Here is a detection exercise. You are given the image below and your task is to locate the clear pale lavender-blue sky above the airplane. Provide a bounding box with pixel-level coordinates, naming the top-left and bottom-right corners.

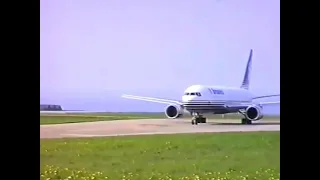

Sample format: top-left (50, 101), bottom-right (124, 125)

top-left (40, 0), bottom-right (280, 111)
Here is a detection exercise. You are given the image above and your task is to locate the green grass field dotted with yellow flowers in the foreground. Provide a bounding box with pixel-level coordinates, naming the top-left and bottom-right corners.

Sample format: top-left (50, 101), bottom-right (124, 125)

top-left (40, 132), bottom-right (280, 180)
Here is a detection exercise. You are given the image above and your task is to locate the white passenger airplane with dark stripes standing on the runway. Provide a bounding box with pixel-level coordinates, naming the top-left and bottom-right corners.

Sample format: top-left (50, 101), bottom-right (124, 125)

top-left (122, 49), bottom-right (280, 125)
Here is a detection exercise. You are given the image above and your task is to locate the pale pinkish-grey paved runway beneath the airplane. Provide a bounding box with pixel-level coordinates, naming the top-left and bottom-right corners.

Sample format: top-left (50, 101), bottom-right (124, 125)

top-left (40, 119), bottom-right (280, 139)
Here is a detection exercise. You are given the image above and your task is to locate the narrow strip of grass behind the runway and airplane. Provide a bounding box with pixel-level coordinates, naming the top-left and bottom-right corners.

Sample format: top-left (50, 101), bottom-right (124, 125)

top-left (40, 113), bottom-right (279, 125)
